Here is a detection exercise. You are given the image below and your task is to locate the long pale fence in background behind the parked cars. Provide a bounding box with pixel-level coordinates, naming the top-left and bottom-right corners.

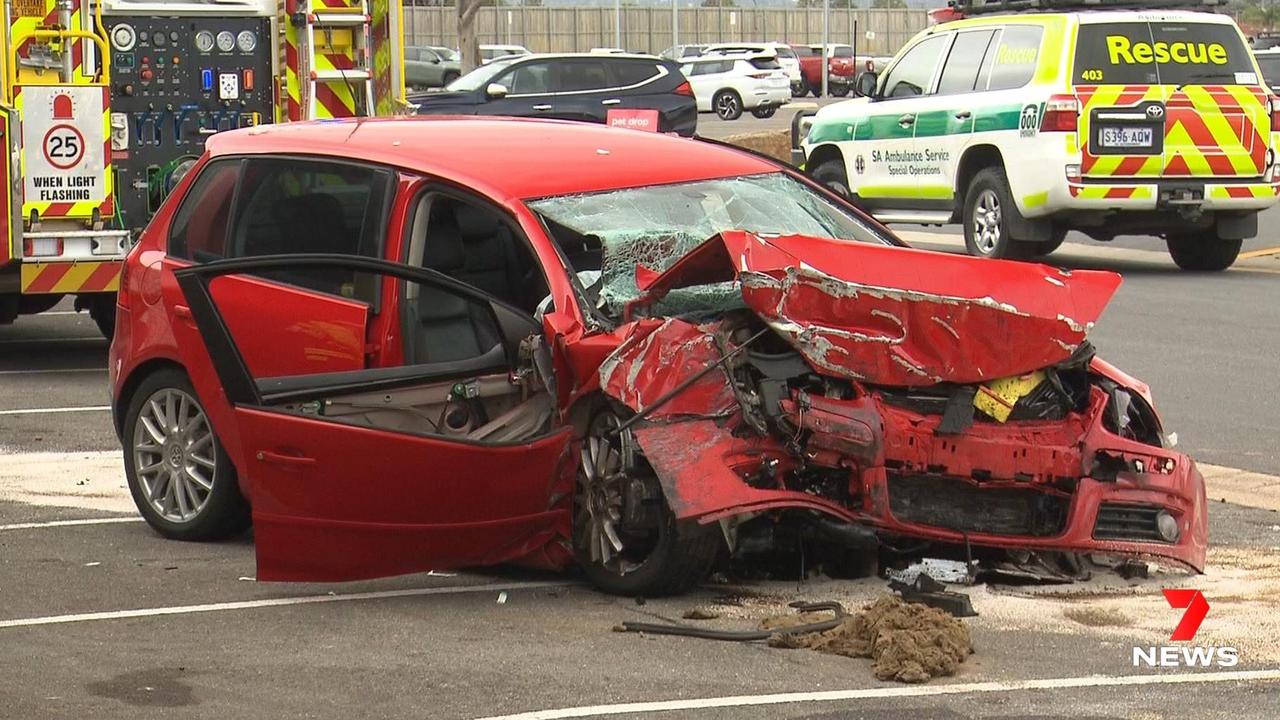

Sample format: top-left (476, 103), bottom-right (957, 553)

top-left (404, 6), bottom-right (928, 55)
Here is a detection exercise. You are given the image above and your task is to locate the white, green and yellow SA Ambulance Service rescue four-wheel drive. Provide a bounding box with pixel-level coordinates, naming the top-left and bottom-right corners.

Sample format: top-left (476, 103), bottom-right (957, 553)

top-left (803, 0), bottom-right (1280, 270)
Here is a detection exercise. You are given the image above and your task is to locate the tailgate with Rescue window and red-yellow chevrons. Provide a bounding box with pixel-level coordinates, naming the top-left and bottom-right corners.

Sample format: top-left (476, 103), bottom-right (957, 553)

top-left (1073, 17), bottom-right (1271, 181)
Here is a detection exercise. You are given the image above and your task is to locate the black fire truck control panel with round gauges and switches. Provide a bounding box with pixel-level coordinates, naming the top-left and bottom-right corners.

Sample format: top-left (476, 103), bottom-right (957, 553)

top-left (102, 15), bottom-right (274, 227)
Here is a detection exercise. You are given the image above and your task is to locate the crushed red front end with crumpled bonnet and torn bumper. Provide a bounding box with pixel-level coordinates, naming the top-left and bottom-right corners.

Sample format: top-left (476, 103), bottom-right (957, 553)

top-left (600, 233), bottom-right (1208, 570)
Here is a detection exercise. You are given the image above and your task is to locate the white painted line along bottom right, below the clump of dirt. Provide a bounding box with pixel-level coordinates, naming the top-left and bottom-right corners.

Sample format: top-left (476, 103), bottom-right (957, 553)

top-left (477, 670), bottom-right (1280, 720)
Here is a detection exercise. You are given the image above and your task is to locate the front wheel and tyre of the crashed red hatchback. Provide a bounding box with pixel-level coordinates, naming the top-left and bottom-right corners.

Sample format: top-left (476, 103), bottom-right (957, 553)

top-left (573, 409), bottom-right (724, 597)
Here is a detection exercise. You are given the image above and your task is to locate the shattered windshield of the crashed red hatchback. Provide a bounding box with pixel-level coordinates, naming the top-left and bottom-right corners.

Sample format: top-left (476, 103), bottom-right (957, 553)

top-left (529, 173), bottom-right (890, 319)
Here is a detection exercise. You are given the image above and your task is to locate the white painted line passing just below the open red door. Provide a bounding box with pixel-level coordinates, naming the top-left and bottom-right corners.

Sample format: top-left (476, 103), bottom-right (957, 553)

top-left (0, 582), bottom-right (573, 630)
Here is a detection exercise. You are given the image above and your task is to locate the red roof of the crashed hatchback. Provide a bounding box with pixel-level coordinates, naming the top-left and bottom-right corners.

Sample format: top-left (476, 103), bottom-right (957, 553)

top-left (205, 115), bottom-right (778, 202)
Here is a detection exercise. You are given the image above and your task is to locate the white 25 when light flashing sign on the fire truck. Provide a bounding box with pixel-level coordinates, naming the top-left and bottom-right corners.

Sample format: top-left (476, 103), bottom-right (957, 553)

top-left (19, 85), bottom-right (106, 202)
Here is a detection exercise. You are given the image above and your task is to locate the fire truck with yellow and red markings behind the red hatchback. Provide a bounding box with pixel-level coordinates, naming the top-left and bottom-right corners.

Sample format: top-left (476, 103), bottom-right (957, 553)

top-left (0, 0), bottom-right (407, 337)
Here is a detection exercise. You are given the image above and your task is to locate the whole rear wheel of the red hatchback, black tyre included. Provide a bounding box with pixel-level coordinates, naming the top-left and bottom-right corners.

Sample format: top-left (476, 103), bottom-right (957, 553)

top-left (122, 368), bottom-right (250, 541)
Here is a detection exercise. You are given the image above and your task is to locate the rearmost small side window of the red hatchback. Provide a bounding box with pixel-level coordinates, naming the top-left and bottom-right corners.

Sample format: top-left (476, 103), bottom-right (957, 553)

top-left (169, 160), bottom-right (241, 263)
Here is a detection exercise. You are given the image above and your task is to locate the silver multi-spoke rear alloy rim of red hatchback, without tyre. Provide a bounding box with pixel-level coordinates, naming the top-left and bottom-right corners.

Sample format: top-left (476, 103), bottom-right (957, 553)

top-left (133, 387), bottom-right (218, 523)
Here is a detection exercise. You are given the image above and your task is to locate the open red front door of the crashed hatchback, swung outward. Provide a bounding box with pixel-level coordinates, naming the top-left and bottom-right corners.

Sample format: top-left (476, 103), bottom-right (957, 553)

top-left (174, 255), bottom-right (572, 582)
